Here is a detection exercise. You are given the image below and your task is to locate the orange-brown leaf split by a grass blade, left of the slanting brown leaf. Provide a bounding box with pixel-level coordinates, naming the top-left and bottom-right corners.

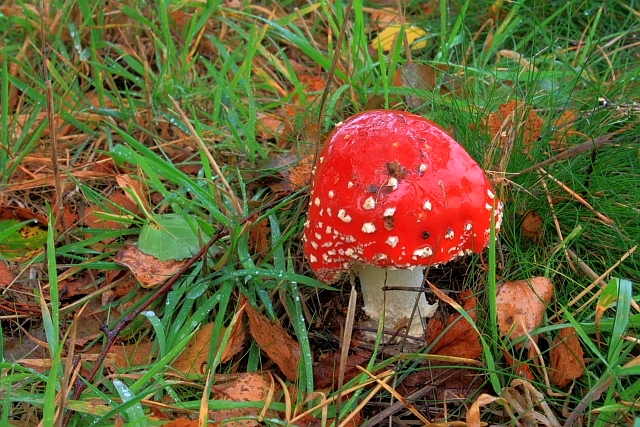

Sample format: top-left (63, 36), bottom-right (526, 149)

top-left (171, 320), bottom-right (246, 375)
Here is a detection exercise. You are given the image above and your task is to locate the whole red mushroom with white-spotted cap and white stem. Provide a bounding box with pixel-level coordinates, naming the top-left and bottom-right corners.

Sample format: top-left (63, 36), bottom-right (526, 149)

top-left (303, 110), bottom-right (502, 336)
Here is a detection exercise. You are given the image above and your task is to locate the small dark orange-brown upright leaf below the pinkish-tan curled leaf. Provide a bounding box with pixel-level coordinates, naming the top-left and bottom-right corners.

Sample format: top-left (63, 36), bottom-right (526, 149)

top-left (549, 327), bottom-right (585, 387)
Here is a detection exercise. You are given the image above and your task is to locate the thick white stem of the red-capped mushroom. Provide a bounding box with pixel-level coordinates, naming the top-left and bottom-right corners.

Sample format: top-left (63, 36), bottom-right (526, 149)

top-left (353, 264), bottom-right (438, 337)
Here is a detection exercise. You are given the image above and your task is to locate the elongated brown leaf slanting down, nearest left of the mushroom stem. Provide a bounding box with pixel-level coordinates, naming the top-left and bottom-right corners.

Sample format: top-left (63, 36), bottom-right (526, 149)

top-left (246, 304), bottom-right (300, 381)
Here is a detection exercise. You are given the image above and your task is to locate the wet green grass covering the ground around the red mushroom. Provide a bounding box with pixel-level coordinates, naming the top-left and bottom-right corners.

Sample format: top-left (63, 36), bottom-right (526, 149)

top-left (0, 0), bottom-right (640, 426)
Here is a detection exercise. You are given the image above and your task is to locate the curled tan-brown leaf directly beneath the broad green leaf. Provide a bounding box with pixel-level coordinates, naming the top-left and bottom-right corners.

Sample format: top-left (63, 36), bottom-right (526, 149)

top-left (115, 245), bottom-right (189, 288)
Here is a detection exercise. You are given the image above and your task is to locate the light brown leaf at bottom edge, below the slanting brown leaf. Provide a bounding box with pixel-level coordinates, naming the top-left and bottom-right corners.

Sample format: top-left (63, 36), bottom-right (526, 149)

top-left (209, 372), bottom-right (269, 427)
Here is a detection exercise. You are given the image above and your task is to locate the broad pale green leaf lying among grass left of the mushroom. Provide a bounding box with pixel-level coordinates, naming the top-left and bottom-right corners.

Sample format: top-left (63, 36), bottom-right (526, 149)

top-left (138, 214), bottom-right (211, 262)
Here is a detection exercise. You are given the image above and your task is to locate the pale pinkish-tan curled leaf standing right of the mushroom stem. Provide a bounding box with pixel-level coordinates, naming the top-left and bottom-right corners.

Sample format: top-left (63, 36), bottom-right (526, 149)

top-left (496, 277), bottom-right (553, 348)
